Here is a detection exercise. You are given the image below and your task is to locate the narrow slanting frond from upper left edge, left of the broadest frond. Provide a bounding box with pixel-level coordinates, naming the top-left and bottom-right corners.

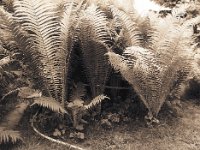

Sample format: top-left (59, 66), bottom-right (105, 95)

top-left (0, 6), bottom-right (50, 95)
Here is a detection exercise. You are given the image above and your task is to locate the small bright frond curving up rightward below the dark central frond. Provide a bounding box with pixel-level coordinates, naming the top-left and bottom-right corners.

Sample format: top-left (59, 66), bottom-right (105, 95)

top-left (84, 95), bottom-right (110, 110)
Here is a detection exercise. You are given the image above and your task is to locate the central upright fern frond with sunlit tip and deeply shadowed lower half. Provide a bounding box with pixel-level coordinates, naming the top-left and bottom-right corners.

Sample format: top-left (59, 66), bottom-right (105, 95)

top-left (79, 5), bottom-right (110, 97)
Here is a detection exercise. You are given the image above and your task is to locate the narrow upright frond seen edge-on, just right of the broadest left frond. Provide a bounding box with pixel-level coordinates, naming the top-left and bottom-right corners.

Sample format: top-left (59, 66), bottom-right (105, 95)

top-left (60, 0), bottom-right (81, 106)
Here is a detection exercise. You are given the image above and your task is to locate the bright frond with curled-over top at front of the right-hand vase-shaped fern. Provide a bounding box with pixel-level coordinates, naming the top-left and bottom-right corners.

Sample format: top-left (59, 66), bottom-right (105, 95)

top-left (109, 47), bottom-right (161, 113)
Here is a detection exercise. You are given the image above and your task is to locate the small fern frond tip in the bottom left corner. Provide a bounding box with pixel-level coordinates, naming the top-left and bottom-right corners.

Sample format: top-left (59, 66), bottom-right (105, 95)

top-left (0, 127), bottom-right (22, 144)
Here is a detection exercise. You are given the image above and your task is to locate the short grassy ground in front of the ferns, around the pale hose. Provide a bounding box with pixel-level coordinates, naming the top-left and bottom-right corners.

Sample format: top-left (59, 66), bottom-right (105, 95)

top-left (12, 101), bottom-right (200, 150)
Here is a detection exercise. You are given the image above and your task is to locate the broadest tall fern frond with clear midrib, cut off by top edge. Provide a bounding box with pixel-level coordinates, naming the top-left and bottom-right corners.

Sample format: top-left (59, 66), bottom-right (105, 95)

top-left (14, 0), bottom-right (64, 100)
